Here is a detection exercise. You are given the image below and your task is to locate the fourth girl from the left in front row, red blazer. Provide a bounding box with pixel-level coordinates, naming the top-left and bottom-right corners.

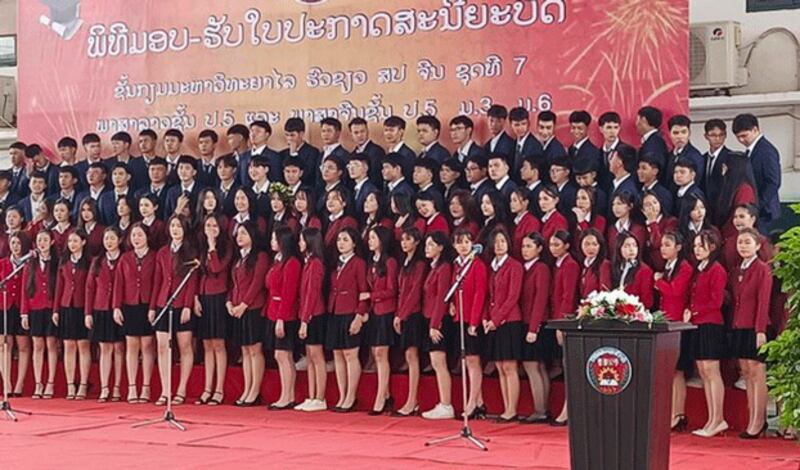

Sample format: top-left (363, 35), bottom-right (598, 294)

top-left (84, 226), bottom-right (125, 403)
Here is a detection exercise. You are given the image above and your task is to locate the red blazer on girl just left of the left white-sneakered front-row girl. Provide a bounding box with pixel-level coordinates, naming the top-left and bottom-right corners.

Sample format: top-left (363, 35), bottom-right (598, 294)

top-left (264, 256), bottom-right (303, 321)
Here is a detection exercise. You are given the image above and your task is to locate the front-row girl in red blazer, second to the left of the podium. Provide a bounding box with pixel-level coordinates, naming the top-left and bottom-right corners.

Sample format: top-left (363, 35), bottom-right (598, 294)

top-left (520, 232), bottom-right (555, 423)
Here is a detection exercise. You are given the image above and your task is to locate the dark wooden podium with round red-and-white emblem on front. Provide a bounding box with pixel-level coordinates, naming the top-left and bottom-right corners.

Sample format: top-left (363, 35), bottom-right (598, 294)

top-left (548, 320), bottom-right (695, 470)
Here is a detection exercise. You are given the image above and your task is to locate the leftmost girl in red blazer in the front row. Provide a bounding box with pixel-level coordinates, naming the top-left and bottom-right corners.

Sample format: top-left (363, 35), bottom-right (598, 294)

top-left (0, 231), bottom-right (31, 397)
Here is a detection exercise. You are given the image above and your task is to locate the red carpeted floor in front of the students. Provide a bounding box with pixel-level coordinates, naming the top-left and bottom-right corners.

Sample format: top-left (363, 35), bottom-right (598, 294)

top-left (0, 398), bottom-right (800, 470)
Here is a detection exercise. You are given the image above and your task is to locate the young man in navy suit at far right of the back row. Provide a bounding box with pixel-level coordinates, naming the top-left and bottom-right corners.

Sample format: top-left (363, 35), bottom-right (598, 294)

top-left (733, 114), bottom-right (781, 231)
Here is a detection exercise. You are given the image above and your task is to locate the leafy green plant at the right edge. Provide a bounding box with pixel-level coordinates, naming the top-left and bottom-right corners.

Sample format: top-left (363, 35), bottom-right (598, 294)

top-left (762, 204), bottom-right (800, 429)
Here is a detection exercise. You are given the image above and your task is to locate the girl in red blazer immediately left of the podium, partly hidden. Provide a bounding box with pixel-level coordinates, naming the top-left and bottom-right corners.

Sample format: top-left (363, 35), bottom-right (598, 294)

top-left (549, 230), bottom-right (580, 426)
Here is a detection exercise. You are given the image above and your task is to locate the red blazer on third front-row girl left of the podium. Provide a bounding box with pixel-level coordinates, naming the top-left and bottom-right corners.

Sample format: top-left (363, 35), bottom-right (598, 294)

top-left (488, 256), bottom-right (525, 327)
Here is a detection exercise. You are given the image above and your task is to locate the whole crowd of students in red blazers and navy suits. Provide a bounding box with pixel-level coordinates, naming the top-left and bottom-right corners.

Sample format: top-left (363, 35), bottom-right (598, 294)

top-left (0, 105), bottom-right (785, 438)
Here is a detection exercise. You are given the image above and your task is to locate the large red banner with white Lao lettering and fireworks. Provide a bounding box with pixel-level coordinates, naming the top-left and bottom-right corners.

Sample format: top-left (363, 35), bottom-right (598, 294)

top-left (18, 0), bottom-right (688, 156)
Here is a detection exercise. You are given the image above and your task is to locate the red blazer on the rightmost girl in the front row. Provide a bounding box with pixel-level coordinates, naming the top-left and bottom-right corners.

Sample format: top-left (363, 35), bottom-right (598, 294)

top-left (730, 259), bottom-right (772, 333)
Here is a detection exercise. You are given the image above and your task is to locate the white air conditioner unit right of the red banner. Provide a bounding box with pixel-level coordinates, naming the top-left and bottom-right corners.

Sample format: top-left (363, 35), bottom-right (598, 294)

top-left (689, 21), bottom-right (747, 91)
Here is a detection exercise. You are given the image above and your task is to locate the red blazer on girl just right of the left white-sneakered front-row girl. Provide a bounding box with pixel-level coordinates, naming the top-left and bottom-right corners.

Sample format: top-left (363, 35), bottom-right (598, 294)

top-left (328, 253), bottom-right (369, 315)
